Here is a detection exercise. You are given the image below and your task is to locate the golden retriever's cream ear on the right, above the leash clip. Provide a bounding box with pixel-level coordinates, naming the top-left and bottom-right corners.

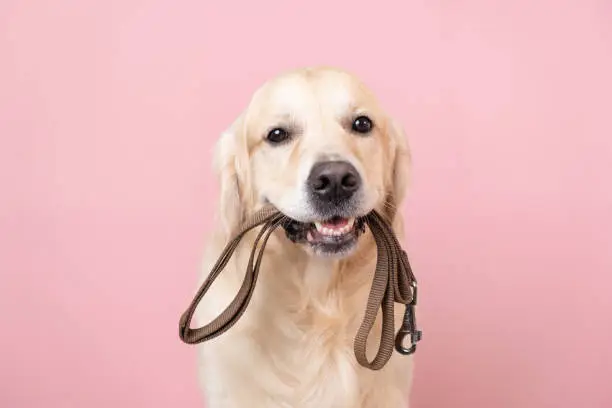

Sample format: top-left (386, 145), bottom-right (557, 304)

top-left (388, 119), bottom-right (412, 214)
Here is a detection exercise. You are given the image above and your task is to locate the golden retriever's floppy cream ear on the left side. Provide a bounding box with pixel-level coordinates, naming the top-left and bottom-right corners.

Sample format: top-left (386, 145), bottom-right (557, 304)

top-left (213, 115), bottom-right (249, 237)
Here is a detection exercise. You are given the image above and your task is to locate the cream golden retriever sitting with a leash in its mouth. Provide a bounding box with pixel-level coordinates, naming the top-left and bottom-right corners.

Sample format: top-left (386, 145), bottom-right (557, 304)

top-left (195, 67), bottom-right (413, 408)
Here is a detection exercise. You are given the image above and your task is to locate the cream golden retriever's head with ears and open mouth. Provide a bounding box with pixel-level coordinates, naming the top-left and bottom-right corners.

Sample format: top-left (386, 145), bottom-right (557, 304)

top-left (215, 68), bottom-right (410, 256)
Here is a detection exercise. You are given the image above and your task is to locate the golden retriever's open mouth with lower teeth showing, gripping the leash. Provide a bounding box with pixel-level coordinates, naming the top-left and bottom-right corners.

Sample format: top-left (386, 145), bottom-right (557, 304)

top-left (283, 216), bottom-right (365, 255)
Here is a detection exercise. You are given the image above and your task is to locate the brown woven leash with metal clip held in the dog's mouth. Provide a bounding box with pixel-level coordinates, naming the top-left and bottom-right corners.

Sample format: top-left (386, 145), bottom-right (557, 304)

top-left (179, 207), bottom-right (421, 370)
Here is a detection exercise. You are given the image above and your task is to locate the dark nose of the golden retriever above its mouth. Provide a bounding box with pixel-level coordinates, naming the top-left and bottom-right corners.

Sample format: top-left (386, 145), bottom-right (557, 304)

top-left (308, 161), bottom-right (361, 203)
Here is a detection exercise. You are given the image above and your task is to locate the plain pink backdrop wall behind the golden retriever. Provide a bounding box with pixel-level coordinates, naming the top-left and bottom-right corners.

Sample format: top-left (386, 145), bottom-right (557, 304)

top-left (0, 0), bottom-right (612, 408)
